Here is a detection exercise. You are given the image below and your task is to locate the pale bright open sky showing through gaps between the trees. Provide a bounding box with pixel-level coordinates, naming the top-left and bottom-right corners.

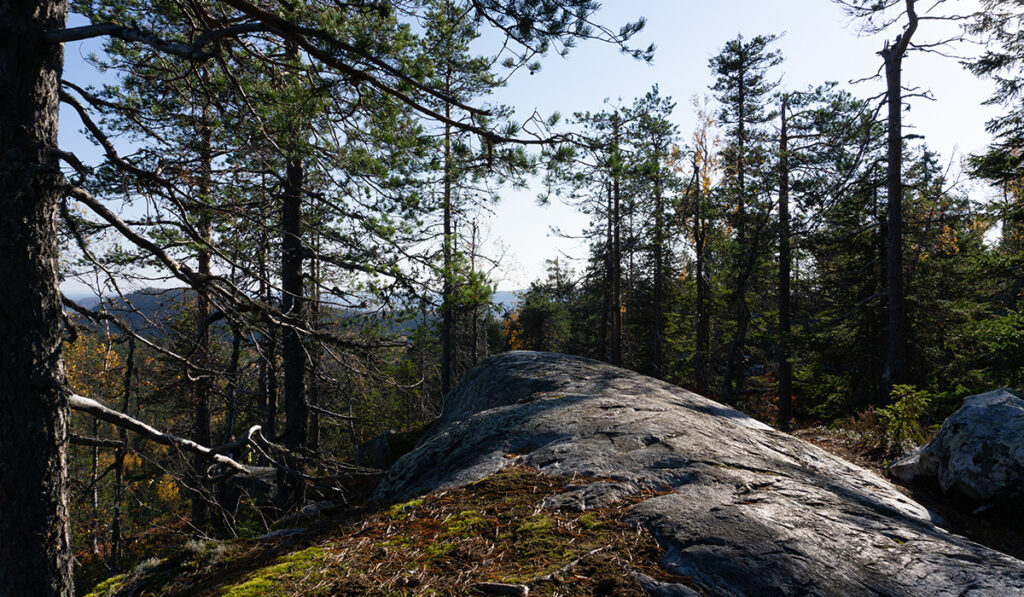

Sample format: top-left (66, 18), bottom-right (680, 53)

top-left (60, 0), bottom-right (997, 292)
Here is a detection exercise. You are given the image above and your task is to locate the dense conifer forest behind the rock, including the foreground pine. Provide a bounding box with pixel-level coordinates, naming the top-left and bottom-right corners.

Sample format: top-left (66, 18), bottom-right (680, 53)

top-left (0, 0), bottom-right (1024, 595)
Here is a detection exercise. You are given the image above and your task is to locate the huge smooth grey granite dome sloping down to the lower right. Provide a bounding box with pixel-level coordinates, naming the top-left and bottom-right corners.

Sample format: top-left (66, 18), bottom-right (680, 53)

top-left (375, 352), bottom-right (1024, 596)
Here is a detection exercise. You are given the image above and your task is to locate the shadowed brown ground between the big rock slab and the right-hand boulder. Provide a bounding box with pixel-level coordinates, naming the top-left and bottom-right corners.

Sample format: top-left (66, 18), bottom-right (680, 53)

top-left (793, 426), bottom-right (1024, 560)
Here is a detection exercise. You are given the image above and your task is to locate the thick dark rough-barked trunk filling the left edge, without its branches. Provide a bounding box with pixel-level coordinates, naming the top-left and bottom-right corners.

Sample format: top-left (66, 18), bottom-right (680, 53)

top-left (0, 0), bottom-right (74, 597)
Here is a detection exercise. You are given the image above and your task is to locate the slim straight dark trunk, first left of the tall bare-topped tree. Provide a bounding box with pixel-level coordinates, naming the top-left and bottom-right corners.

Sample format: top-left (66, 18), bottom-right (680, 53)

top-left (778, 95), bottom-right (793, 429)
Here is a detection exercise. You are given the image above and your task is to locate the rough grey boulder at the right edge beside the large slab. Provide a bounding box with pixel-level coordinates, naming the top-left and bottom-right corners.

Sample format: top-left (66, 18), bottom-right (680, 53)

top-left (890, 388), bottom-right (1024, 504)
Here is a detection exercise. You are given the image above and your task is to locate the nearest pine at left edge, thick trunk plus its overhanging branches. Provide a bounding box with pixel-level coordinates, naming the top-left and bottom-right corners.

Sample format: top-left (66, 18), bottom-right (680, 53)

top-left (6, 0), bottom-right (649, 595)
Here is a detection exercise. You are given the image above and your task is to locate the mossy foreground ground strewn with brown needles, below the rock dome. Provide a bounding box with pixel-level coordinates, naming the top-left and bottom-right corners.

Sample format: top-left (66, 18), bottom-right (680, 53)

top-left (81, 467), bottom-right (685, 597)
